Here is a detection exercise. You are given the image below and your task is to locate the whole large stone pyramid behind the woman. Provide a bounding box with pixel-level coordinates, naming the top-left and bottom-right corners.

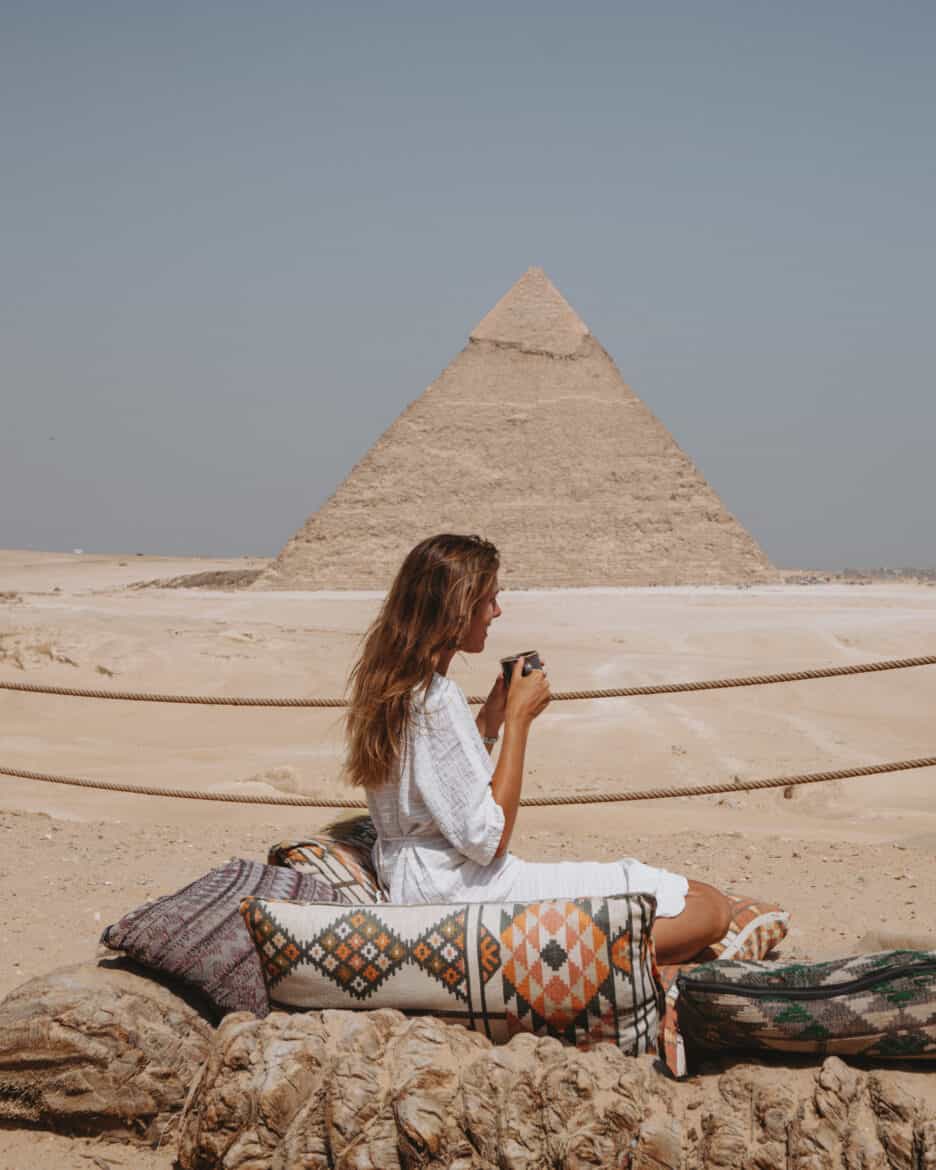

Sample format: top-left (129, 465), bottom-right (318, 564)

top-left (256, 268), bottom-right (776, 590)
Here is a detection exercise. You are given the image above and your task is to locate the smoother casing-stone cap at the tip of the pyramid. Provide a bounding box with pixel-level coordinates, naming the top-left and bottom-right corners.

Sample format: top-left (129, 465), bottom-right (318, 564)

top-left (470, 268), bottom-right (590, 357)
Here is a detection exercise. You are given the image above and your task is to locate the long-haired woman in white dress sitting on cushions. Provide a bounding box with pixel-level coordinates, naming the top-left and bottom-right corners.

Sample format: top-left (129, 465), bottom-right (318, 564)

top-left (347, 535), bottom-right (730, 963)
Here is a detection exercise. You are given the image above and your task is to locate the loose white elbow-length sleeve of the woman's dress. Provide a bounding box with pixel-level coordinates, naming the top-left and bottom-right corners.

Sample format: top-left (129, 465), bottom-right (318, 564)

top-left (414, 680), bottom-right (504, 866)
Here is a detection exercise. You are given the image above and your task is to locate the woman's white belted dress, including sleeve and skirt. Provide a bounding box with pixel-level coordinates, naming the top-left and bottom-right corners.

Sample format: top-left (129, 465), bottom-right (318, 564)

top-left (367, 674), bottom-right (688, 917)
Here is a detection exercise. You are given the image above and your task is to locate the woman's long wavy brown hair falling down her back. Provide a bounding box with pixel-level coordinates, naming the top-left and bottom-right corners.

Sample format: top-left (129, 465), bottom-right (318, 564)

top-left (345, 534), bottom-right (500, 789)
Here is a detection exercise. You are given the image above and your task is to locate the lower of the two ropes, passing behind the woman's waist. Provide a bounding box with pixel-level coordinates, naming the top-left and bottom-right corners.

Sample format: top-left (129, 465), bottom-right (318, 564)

top-left (0, 756), bottom-right (936, 808)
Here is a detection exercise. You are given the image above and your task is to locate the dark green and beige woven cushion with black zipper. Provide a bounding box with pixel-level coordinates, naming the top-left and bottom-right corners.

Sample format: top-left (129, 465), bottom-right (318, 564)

top-left (677, 950), bottom-right (936, 1060)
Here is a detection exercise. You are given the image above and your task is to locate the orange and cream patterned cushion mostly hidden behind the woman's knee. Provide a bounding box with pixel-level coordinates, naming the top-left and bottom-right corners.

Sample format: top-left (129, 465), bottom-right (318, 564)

top-left (660, 894), bottom-right (790, 1076)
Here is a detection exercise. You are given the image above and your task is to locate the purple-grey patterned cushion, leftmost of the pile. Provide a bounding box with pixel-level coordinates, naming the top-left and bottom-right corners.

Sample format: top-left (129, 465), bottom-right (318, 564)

top-left (101, 858), bottom-right (337, 1016)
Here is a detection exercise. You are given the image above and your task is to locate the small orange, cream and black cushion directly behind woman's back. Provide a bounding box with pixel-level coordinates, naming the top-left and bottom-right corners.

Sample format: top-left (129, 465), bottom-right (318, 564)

top-left (267, 817), bottom-right (386, 906)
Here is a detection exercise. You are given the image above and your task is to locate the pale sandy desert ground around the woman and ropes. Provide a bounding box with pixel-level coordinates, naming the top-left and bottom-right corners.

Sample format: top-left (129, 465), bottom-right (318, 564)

top-left (0, 551), bottom-right (936, 1170)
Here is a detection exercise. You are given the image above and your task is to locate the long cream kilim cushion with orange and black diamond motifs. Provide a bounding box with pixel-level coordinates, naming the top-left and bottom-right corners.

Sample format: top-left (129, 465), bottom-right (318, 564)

top-left (241, 894), bottom-right (660, 1054)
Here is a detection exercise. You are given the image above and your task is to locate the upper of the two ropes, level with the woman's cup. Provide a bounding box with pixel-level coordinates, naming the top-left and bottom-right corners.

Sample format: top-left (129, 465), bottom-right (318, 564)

top-left (0, 654), bottom-right (936, 708)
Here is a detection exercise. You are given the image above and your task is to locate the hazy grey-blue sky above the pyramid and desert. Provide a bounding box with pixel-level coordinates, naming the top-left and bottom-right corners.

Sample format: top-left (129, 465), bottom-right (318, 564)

top-left (0, 0), bottom-right (936, 567)
